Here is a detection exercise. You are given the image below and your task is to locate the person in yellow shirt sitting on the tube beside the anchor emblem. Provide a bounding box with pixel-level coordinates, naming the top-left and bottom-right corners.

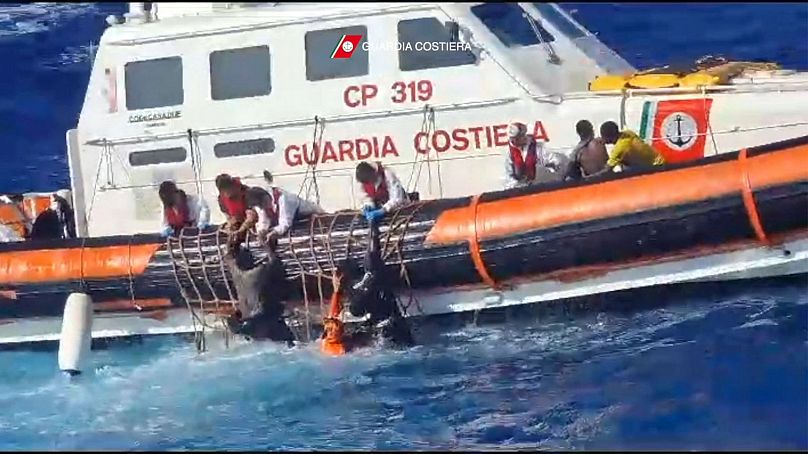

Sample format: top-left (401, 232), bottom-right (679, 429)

top-left (597, 121), bottom-right (665, 175)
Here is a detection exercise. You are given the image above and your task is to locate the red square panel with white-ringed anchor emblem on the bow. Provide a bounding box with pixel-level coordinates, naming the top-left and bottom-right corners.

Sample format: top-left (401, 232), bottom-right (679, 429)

top-left (640, 98), bottom-right (713, 162)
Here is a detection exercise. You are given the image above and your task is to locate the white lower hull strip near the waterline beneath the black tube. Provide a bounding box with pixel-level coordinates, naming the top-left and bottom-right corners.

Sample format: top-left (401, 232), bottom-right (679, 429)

top-left (0, 239), bottom-right (808, 344)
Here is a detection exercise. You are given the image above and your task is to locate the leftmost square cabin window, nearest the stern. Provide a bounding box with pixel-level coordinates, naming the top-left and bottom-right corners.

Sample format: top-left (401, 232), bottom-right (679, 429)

top-left (124, 57), bottom-right (184, 110)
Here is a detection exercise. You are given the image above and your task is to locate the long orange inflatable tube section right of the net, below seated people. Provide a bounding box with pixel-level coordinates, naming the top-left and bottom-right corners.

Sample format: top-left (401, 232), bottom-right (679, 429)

top-left (426, 145), bottom-right (808, 245)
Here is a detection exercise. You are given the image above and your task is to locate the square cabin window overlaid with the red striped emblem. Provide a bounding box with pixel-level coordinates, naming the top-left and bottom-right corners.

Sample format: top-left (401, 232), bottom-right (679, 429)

top-left (304, 25), bottom-right (369, 81)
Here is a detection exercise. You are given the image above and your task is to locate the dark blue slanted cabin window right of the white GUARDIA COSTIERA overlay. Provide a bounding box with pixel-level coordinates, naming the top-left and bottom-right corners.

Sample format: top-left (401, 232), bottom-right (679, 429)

top-left (471, 3), bottom-right (555, 47)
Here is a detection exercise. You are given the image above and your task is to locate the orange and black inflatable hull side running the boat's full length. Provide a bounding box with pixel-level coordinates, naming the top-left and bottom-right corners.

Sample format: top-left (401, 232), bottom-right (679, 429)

top-left (0, 136), bottom-right (808, 344)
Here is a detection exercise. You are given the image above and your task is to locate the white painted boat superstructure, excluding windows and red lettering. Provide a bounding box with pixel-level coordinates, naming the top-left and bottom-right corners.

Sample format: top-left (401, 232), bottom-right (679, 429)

top-left (70, 3), bottom-right (808, 236)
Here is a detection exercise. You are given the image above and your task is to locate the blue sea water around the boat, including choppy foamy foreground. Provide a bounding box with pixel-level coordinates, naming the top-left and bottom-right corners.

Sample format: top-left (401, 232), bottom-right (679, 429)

top-left (0, 3), bottom-right (808, 450)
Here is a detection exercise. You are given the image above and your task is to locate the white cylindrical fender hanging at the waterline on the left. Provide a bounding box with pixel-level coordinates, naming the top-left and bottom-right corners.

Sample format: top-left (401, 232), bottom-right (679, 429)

top-left (59, 293), bottom-right (93, 376)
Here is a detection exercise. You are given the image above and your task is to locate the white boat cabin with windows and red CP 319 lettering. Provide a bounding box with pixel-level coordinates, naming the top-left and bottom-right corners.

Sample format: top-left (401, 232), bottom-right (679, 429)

top-left (67, 2), bottom-right (808, 236)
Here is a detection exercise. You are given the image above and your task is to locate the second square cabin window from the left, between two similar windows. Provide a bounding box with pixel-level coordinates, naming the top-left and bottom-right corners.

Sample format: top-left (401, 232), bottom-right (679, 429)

top-left (210, 46), bottom-right (272, 101)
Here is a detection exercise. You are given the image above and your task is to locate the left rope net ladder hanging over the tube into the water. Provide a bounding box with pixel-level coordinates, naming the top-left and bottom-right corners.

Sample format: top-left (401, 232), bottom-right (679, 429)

top-left (166, 228), bottom-right (236, 353)
